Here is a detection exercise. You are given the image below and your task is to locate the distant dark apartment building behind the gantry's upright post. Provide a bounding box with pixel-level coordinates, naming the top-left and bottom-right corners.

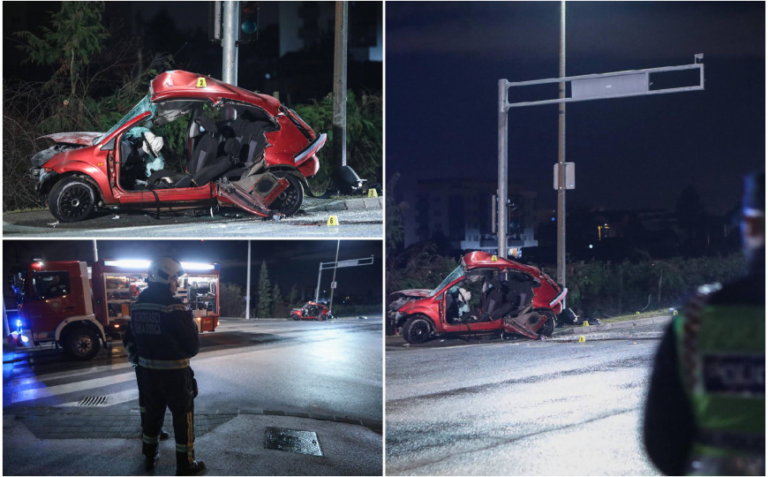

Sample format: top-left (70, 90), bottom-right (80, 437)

top-left (403, 179), bottom-right (538, 253)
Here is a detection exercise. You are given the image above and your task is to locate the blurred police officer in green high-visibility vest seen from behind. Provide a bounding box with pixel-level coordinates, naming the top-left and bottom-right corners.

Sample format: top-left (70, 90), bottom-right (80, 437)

top-left (644, 173), bottom-right (765, 475)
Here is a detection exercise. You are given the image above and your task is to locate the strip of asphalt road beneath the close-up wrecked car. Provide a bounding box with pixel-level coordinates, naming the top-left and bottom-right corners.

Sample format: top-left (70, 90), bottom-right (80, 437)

top-left (3, 198), bottom-right (383, 238)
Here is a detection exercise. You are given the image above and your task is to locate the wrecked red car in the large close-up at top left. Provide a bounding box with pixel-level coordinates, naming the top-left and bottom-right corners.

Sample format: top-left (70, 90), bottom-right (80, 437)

top-left (30, 70), bottom-right (326, 222)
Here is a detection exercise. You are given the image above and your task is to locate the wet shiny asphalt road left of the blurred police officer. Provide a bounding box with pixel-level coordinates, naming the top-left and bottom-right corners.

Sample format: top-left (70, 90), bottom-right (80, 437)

top-left (386, 325), bottom-right (663, 475)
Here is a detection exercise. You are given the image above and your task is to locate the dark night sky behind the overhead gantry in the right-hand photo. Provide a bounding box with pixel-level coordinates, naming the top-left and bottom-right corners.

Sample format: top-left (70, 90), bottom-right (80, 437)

top-left (386, 2), bottom-right (765, 213)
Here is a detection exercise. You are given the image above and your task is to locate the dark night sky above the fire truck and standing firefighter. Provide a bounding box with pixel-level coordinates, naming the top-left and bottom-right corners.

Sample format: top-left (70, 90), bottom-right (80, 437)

top-left (3, 240), bottom-right (382, 297)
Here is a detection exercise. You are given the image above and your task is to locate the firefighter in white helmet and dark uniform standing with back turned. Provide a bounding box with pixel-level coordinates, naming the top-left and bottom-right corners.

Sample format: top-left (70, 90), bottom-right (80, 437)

top-left (130, 257), bottom-right (205, 475)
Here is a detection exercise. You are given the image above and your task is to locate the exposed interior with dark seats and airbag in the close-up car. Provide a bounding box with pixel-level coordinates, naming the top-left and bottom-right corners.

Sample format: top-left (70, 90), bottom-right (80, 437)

top-left (119, 101), bottom-right (278, 191)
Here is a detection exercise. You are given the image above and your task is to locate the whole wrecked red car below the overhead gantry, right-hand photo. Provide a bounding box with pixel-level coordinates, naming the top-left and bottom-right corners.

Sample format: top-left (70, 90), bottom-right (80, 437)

top-left (387, 252), bottom-right (568, 344)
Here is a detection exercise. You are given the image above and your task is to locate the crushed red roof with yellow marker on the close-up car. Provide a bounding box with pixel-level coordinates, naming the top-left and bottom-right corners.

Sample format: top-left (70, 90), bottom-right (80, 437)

top-left (150, 70), bottom-right (280, 116)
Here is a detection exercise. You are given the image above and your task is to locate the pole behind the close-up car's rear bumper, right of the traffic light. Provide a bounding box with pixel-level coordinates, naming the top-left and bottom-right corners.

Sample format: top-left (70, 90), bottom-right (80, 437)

top-left (333, 1), bottom-right (349, 166)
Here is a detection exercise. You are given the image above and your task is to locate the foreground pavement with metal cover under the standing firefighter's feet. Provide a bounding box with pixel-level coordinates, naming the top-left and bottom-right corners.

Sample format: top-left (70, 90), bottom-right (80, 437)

top-left (3, 409), bottom-right (383, 475)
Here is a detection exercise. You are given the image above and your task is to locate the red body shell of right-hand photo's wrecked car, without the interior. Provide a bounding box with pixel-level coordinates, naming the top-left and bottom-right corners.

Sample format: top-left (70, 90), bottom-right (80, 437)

top-left (387, 252), bottom-right (568, 343)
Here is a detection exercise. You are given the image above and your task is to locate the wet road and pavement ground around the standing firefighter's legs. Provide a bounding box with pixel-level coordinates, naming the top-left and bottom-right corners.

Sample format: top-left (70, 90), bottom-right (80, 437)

top-left (3, 316), bottom-right (383, 475)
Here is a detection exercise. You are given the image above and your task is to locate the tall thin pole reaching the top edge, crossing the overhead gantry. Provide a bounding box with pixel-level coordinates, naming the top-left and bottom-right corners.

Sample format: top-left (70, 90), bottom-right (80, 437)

top-left (557, 0), bottom-right (565, 287)
